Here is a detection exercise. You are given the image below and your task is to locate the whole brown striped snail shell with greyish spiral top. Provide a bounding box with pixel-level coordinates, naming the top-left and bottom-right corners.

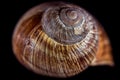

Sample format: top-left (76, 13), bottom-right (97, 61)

top-left (12, 2), bottom-right (113, 77)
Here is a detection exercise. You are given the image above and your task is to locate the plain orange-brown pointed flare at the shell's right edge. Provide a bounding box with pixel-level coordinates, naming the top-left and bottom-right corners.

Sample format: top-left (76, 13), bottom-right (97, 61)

top-left (91, 25), bottom-right (114, 66)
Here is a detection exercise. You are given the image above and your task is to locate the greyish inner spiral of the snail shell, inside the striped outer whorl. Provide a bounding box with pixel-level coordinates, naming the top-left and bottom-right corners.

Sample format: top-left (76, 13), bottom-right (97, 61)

top-left (42, 5), bottom-right (92, 44)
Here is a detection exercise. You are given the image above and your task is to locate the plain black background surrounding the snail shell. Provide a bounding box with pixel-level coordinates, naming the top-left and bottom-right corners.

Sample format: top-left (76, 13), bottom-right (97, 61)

top-left (0, 0), bottom-right (120, 80)
